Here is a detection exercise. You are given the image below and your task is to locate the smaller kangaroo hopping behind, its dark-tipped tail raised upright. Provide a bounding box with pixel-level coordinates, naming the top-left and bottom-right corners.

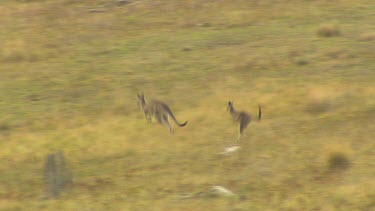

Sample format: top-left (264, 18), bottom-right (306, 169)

top-left (227, 101), bottom-right (262, 140)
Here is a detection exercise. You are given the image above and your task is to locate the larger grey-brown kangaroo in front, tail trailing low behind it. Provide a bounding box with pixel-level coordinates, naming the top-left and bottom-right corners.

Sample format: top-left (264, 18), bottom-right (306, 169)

top-left (137, 93), bottom-right (187, 134)
